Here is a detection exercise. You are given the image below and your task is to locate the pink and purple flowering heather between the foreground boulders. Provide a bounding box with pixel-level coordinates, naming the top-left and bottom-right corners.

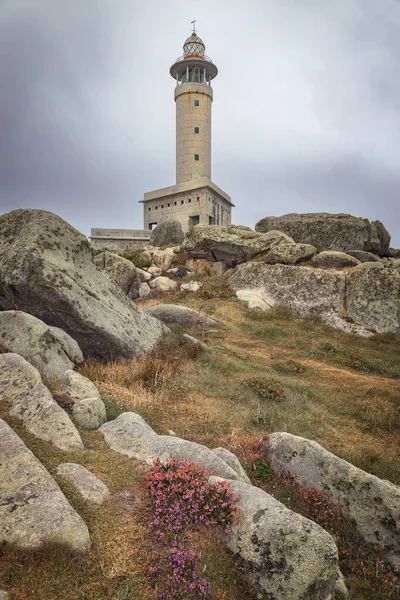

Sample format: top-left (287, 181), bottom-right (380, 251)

top-left (146, 459), bottom-right (238, 600)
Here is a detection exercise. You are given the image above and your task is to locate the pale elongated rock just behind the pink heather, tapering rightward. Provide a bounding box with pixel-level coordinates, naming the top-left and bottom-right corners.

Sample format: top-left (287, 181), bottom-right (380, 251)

top-left (100, 412), bottom-right (245, 479)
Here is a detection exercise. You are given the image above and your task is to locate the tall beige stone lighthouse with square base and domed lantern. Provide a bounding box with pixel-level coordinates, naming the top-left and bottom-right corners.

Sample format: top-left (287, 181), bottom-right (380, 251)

top-left (140, 21), bottom-right (234, 231)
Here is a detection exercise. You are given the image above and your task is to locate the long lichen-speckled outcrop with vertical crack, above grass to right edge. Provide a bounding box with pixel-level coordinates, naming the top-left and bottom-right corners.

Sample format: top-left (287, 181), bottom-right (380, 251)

top-left (227, 262), bottom-right (400, 335)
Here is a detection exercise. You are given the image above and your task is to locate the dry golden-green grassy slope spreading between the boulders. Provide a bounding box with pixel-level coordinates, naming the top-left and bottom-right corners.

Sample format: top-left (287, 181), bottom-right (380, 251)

top-left (0, 295), bottom-right (400, 600)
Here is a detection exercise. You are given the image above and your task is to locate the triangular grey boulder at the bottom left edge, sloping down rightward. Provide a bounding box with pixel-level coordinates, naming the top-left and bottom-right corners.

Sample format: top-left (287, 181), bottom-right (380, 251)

top-left (0, 419), bottom-right (90, 554)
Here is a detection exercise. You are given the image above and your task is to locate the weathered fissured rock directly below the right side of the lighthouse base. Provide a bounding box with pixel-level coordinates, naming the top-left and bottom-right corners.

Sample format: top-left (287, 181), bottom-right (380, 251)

top-left (183, 225), bottom-right (316, 270)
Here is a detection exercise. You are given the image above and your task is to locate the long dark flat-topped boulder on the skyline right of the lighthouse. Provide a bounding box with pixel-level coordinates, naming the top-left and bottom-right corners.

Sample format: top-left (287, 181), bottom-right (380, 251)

top-left (256, 213), bottom-right (390, 256)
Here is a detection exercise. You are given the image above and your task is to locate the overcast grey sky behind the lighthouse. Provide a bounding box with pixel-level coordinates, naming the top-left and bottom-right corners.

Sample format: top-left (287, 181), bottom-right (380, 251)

top-left (0, 0), bottom-right (400, 247)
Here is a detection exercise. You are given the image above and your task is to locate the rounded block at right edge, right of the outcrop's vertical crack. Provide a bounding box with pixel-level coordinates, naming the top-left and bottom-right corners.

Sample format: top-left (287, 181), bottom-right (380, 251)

top-left (346, 263), bottom-right (400, 333)
